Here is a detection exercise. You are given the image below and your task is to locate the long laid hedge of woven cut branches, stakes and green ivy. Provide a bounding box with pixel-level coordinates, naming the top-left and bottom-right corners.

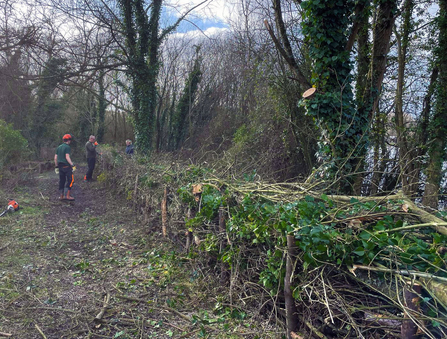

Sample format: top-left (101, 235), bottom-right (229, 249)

top-left (100, 153), bottom-right (447, 339)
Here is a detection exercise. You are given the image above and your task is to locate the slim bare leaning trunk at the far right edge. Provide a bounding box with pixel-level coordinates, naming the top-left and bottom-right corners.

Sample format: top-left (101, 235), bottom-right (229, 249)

top-left (423, 0), bottom-right (447, 208)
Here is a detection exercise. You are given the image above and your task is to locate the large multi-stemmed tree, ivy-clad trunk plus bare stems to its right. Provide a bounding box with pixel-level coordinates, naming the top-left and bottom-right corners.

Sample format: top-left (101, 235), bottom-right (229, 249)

top-left (301, 0), bottom-right (397, 194)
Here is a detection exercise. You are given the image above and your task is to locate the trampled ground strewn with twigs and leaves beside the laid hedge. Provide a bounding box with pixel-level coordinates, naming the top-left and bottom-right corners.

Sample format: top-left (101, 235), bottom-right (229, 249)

top-left (0, 167), bottom-right (276, 339)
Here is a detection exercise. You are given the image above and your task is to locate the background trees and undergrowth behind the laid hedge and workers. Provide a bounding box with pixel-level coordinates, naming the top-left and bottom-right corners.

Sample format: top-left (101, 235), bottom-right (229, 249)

top-left (0, 0), bottom-right (447, 208)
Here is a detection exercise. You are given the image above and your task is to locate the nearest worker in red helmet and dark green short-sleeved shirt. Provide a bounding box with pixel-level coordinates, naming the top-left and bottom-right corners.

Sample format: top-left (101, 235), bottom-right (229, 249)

top-left (54, 134), bottom-right (76, 201)
